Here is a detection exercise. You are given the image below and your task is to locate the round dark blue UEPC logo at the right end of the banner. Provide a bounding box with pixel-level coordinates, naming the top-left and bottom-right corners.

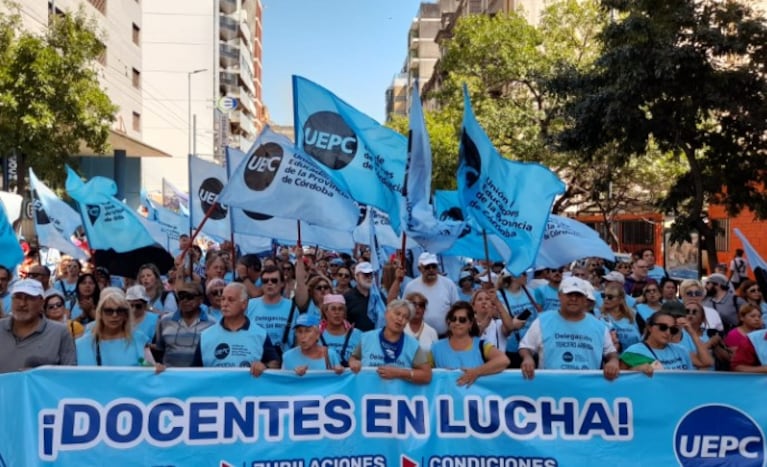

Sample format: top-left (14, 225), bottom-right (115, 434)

top-left (674, 405), bottom-right (765, 467)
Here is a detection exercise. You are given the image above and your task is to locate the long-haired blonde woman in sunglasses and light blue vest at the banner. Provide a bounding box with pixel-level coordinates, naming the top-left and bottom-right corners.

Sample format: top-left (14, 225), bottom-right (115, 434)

top-left (75, 287), bottom-right (154, 366)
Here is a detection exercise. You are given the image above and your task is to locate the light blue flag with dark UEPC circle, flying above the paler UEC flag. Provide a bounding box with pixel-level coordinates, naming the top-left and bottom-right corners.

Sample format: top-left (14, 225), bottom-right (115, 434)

top-left (293, 75), bottom-right (407, 233)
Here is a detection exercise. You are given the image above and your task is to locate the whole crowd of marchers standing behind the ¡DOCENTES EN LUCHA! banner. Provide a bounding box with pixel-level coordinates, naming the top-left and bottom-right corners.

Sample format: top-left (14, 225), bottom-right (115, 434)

top-left (0, 241), bottom-right (767, 386)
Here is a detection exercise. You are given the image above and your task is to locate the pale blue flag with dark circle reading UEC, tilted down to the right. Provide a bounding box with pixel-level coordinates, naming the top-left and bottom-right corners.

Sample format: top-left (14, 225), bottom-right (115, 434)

top-left (218, 126), bottom-right (360, 232)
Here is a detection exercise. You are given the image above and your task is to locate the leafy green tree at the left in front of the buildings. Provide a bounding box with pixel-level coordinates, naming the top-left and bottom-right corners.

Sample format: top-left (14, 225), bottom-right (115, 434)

top-left (0, 3), bottom-right (117, 193)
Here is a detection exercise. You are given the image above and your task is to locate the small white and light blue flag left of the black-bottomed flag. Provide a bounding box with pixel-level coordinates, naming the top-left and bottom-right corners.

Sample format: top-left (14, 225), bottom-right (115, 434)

top-left (29, 167), bottom-right (89, 260)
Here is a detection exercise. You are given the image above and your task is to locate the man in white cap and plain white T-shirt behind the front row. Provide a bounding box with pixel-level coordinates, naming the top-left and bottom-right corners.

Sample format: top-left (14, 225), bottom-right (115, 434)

top-left (405, 252), bottom-right (458, 338)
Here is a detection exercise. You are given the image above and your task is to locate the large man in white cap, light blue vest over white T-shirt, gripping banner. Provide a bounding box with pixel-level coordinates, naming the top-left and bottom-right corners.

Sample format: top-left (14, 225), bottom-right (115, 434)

top-left (519, 276), bottom-right (620, 380)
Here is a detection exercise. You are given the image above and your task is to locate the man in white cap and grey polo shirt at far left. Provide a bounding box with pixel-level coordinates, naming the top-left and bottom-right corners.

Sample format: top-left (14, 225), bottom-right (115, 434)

top-left (0, 279), bottom-right (77, 373)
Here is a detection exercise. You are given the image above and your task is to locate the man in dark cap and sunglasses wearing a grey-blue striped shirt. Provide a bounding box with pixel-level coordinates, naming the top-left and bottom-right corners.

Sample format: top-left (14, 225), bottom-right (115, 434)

top-left (155, 282), bottom-right (216, 367)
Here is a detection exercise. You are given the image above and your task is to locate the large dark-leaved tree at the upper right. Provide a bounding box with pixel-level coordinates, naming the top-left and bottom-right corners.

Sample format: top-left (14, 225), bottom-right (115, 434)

top-left (551, 0), bottom-right (767, 272)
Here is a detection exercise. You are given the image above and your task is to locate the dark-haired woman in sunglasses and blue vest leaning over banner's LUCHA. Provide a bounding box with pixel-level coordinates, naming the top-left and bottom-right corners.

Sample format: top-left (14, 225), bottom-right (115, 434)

top-left (431, 301), bottom-right (509, 386)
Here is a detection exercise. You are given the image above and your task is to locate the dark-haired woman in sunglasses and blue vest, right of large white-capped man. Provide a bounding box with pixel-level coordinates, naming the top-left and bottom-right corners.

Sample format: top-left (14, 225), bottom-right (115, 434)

top-left (620, 311), bottom-right (714, 376)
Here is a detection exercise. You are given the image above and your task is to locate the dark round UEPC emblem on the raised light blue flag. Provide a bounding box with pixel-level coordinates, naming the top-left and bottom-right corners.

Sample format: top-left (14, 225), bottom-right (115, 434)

top-left (304, 111), bottom-right (357, 170)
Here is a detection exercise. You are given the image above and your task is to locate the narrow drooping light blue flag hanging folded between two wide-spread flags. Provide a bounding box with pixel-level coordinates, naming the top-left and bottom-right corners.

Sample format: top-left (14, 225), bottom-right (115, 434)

top-left (400, 81), bottom-right (464, 253)
